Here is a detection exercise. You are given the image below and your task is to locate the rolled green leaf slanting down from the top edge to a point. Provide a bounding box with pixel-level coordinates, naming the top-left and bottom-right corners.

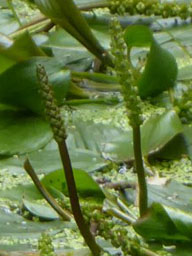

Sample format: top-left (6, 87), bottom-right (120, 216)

top-left (35, 0), bottom-right (111, 64)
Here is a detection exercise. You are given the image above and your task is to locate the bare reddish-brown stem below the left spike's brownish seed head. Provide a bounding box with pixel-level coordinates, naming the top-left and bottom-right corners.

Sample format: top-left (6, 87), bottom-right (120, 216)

top-left (58, 140), bottom-right (101, 256)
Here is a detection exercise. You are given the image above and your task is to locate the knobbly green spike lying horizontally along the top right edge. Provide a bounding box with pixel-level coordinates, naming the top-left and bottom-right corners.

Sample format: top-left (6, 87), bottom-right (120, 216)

top-left (110, 0), bottom-right (192, 19)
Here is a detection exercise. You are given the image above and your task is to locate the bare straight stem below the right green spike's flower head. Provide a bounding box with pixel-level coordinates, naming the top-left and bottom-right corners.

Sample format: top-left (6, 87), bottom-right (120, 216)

top-left (133, 125), bottom-right (148, 216)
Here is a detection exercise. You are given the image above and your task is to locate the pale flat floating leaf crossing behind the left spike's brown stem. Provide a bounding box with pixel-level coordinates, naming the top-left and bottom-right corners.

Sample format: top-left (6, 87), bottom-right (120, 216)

top-left (0, 140), bottom-right (109, 174)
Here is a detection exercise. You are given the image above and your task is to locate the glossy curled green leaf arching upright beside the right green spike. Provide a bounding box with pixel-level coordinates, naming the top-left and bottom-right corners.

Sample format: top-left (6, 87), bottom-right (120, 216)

top-left (125, 25), bottom-right (177, 98)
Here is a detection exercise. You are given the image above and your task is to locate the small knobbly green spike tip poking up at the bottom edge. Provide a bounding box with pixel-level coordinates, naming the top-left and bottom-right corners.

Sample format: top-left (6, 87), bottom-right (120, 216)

top-left (38, 233), bottom-right (57, 256)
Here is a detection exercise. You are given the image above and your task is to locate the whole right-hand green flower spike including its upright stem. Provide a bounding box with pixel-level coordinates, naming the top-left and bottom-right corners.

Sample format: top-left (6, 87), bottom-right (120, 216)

top-left (111, 18), bottom-right (147, 216)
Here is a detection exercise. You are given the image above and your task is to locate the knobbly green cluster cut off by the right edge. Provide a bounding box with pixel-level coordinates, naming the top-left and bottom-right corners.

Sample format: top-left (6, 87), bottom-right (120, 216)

top-left (175, 85), bottom-right (192, 124)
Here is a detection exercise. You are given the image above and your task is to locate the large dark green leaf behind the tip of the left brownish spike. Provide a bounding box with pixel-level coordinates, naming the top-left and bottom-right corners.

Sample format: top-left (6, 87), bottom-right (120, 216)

top-left (0, 57), bottom-right (70, 114)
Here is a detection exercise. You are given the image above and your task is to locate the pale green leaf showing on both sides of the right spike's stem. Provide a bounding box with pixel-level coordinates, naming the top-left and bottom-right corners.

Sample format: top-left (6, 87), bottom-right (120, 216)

top-left (104, 110), bottom-right (183, 161)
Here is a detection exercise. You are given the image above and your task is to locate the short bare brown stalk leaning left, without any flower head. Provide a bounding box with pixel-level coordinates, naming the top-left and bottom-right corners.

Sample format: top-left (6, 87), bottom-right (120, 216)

top-left (24, 159), bottom-right (72, 221)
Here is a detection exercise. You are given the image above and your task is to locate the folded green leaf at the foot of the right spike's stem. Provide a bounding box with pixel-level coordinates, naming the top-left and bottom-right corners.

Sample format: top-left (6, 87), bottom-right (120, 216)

top-left (133, 203), bottom-right (192, 241)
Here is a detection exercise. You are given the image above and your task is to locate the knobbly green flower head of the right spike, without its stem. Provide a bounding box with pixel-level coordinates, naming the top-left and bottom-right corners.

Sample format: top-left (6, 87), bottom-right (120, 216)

top-left (111, 18), bottom-right (142, 127)
